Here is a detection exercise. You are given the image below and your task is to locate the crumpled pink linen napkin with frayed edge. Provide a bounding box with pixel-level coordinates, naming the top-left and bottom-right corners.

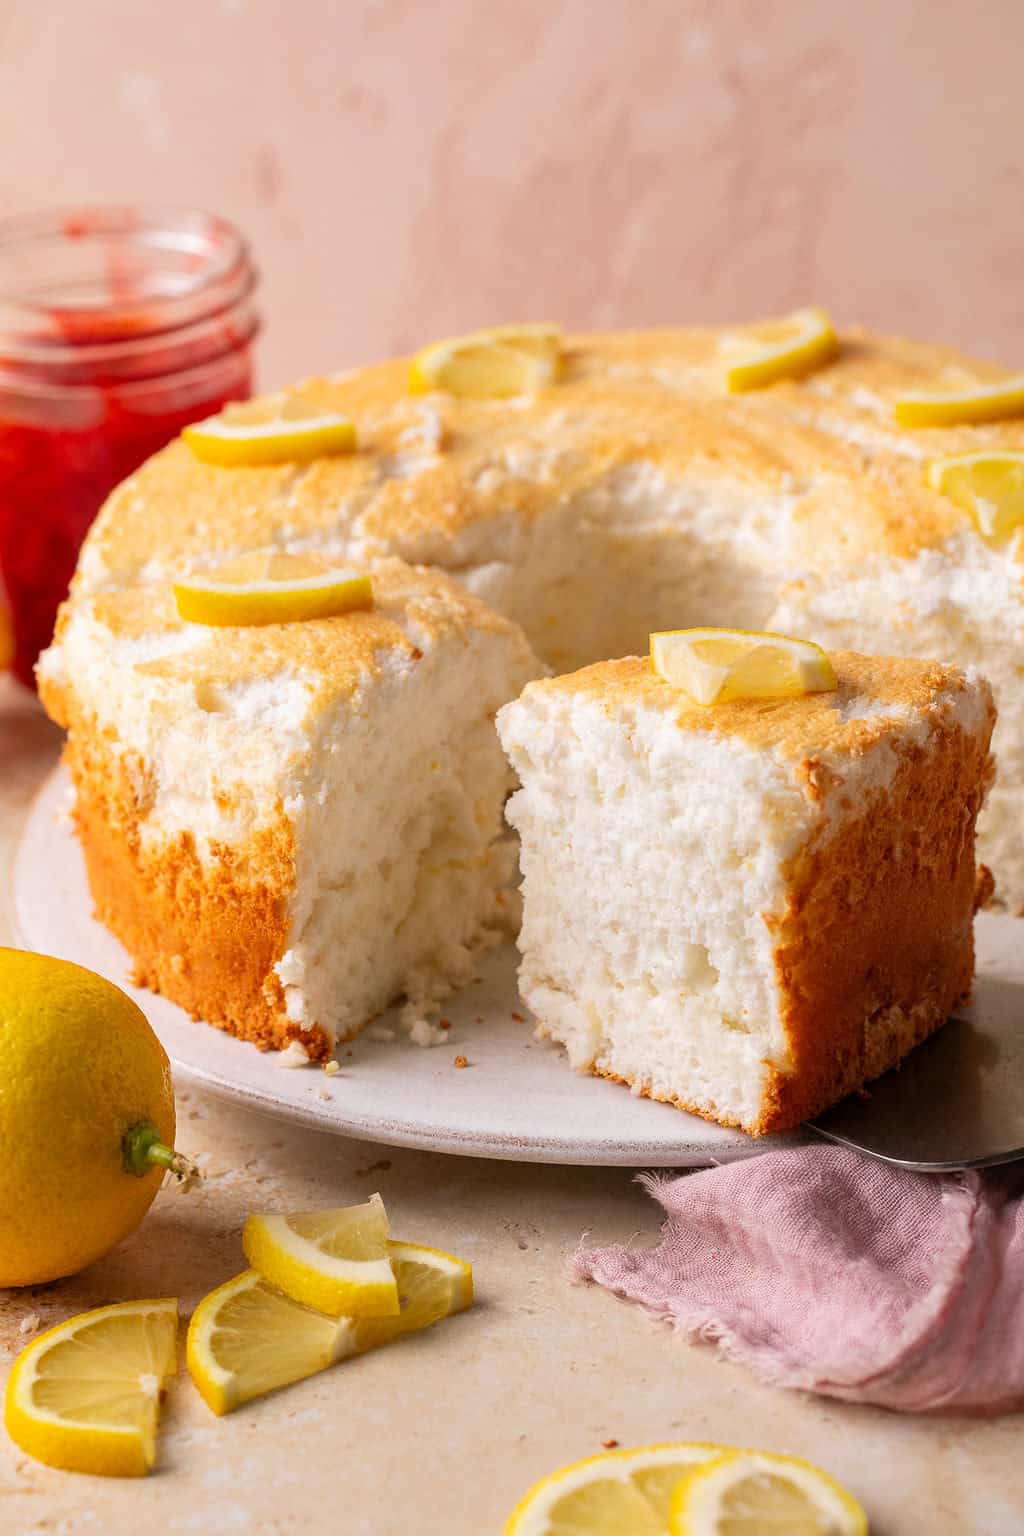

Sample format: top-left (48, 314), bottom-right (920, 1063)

top-left (573, 1144), bottom-right (1024, 1413)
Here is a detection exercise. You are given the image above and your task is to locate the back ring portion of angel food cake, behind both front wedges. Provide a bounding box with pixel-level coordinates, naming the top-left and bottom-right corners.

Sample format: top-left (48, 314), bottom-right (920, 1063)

top-left (43, 317), bottom-right (1024, 909)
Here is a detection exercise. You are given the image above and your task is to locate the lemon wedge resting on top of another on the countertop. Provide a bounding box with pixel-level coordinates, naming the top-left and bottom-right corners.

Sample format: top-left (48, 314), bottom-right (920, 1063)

top-left (241, 1195), bottom-right (398, 1318)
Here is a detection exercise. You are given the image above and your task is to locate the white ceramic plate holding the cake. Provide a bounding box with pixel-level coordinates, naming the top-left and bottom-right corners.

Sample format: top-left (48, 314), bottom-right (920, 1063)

top-left (14, 768), bottom-right (1024, 1167)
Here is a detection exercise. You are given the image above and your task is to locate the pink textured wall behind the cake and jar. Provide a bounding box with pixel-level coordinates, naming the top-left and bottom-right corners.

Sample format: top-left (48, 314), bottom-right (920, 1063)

top-left (0, 0), bottom-right (1024, 384)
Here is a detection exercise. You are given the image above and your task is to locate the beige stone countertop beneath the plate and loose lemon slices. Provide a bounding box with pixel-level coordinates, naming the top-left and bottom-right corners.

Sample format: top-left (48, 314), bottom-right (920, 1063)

top-left (0, 679), bottom-right (1024, 1536)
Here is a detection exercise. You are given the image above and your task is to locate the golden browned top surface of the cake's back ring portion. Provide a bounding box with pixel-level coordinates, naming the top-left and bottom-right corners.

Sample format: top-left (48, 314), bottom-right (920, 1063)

top-left (78, 330), bottom-right (1024, 587)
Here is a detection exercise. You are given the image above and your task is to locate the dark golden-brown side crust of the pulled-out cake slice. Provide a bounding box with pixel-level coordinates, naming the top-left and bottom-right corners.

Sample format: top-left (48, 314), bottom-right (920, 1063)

top-left (757, 691), bottom-right (995, 1132)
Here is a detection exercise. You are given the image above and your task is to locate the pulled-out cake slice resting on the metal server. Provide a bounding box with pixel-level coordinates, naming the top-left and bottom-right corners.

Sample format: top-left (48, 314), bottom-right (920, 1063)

top-left (497, 653), bottom-right (995, 1135)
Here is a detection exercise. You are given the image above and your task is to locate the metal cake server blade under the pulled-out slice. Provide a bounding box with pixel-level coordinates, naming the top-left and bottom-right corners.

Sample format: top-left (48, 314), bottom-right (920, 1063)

top-left (808, 970), bottom-right (1024, 1174)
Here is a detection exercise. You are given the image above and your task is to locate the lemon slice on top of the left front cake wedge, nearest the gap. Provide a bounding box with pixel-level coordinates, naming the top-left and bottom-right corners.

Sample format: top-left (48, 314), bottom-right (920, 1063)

top-left (173, 554), bottom-right (373, 627)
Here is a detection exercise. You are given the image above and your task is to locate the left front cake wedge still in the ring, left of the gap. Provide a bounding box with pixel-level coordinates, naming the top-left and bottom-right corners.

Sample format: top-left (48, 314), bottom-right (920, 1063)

top-left (40, 561), bottom-right (540, 1058)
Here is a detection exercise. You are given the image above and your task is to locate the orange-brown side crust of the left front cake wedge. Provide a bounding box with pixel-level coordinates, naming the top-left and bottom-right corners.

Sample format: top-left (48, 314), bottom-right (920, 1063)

top-left (64, 706), bottom-right (332, 1060)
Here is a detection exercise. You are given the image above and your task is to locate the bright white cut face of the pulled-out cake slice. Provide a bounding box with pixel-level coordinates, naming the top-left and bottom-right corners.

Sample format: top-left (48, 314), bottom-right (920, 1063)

top-left (499, 693), bottom-right (811, 1121)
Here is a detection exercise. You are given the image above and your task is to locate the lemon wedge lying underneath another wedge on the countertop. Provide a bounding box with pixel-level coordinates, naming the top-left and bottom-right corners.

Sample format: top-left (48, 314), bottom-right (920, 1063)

top-left (187, 1243), bottom-right (473, 1413)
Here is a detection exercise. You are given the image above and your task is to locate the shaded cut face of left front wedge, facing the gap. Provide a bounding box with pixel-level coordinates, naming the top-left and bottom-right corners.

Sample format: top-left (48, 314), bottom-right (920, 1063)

top-left (275, 636), bottom-right (525, 1043)
